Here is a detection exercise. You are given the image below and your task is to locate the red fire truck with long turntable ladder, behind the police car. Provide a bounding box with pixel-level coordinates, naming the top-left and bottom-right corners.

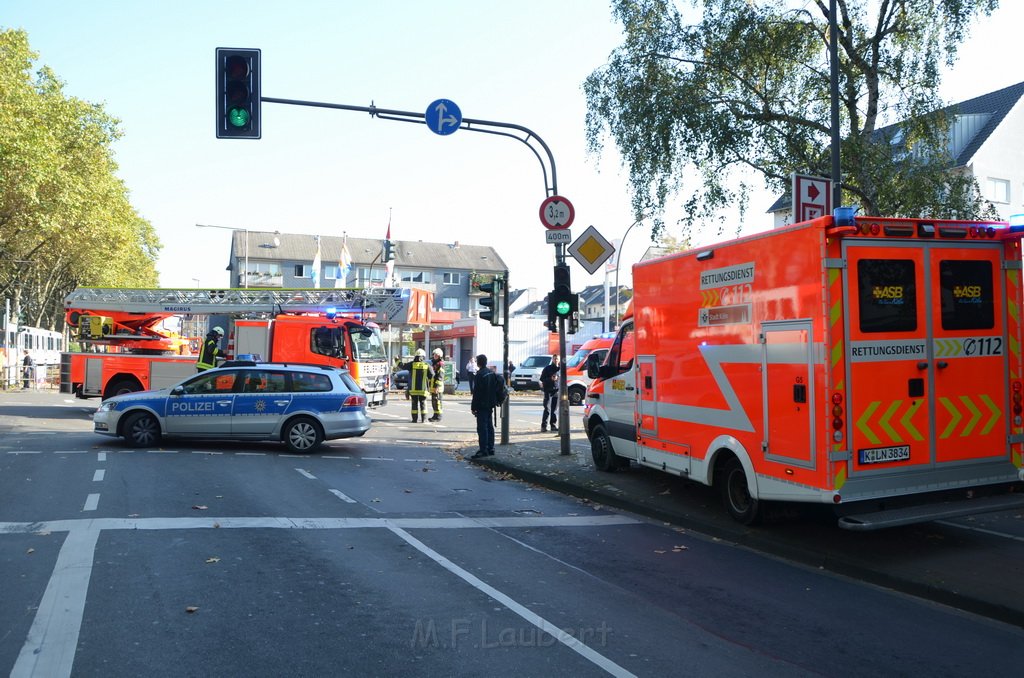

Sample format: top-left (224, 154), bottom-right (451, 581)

top-left (60, 288), bottom-right (409, 407)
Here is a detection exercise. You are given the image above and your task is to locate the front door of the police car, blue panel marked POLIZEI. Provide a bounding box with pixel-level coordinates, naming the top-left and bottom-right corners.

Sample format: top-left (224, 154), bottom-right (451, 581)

top-left (164, 370), bottom-right (238, 436)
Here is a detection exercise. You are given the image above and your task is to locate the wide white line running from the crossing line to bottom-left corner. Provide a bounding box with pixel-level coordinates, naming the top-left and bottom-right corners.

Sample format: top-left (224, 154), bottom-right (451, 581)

top-left (10, 532), bottom-right (99, 678)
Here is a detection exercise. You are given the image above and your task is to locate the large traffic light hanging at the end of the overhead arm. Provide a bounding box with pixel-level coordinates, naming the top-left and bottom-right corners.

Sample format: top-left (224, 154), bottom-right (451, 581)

top-left (215, 47), bottom-right (260, 139)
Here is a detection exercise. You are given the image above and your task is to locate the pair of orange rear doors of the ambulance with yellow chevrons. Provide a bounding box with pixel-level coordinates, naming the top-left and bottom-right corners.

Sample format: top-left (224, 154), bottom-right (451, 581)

top-left (844, 241), bottom-right (1009, 481)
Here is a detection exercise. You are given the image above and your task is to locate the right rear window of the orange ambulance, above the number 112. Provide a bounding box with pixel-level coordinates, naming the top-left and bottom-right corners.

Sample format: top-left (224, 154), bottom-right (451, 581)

top-left (939, 261), bottom-right (995, 330)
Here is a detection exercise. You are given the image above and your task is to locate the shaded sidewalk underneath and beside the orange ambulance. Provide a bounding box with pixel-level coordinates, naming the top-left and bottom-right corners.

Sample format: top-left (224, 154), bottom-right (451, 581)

top-left (466, 428), bottom-right (1024, 627)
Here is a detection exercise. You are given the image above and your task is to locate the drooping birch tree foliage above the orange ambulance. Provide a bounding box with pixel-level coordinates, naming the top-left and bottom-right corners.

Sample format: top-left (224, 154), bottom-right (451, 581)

top-left (584, 0), bottom-right (998, 235)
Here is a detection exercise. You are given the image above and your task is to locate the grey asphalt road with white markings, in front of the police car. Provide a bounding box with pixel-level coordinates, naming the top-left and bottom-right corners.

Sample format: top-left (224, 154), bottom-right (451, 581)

top-left (0, 393), bottom-right (1024, 677)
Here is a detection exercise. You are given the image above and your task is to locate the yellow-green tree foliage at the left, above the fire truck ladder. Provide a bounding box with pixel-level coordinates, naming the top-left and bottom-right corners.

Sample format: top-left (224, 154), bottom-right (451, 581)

top-left (0, 30), bottom-right (161, 329)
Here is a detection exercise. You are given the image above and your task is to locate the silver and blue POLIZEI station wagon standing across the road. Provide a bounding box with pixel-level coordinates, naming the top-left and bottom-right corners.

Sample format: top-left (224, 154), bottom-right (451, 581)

top-left (92, 362), bottom-right (370, 453)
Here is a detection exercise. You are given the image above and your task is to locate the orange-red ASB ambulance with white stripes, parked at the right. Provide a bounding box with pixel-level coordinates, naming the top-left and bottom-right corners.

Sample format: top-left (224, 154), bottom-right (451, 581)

top-left (584, 214), bottom-right (1024, 531)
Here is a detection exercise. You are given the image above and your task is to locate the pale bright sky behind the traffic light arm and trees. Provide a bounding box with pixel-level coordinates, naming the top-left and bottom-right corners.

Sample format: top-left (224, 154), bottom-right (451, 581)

top-left (6, 0), bottom-right (1024, 293)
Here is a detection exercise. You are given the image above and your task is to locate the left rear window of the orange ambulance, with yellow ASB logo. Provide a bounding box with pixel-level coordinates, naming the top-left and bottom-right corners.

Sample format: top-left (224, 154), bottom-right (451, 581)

top-left (857, 259), bottom-right (918, 332)
